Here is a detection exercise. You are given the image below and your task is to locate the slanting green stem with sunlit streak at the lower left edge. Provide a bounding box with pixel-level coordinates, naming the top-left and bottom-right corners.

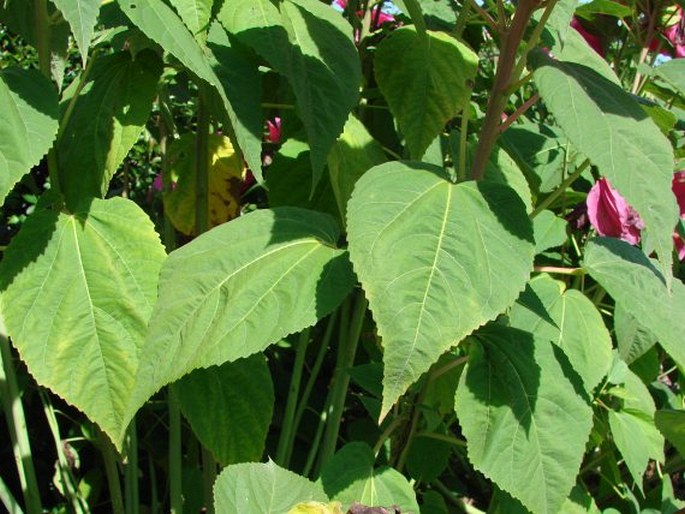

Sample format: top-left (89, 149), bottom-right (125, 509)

top-left (0, 334), bottom-right (43, 514)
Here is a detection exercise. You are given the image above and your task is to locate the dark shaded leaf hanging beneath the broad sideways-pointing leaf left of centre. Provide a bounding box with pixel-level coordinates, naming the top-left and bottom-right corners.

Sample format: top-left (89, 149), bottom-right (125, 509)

top-left (172, 354), bottom-right (274, 466)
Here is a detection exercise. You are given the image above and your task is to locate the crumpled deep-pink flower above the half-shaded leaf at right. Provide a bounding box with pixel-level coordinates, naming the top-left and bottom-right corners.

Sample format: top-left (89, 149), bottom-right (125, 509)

top-left (586, 178), bottom-right (645, 245)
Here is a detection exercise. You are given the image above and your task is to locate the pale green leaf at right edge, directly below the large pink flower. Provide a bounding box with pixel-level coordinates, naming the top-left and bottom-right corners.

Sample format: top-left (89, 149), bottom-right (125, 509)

top-left (583, 238), bottom-right (685, 369)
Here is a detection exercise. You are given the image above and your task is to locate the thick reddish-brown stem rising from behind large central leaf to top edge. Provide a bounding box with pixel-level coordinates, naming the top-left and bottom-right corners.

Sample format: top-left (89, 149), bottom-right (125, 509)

top-left (472, 0), bottom-right (538, 180)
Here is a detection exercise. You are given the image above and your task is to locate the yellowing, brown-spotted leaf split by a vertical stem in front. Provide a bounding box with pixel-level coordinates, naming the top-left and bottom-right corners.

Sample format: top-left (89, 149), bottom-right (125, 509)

top-left (164, 134), bottom-right (243, 235)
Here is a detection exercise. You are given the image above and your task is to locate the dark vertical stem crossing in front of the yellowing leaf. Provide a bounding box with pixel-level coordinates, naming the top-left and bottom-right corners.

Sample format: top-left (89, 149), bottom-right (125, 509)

top-left (195, 85), bottom-right (209, 236)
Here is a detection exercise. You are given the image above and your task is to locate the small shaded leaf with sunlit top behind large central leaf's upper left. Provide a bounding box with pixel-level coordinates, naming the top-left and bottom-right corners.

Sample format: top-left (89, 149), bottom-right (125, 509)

top-left (328, 115), bottom-right (387, 219)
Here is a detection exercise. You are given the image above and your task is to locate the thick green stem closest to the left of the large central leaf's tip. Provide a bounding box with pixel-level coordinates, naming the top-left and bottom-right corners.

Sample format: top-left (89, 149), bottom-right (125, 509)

top-left (319, 290), bottom-right (368, 470)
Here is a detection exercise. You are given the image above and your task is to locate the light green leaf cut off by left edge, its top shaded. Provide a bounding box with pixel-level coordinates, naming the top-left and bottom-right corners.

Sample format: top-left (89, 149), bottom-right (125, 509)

top-left (0, 68), bottom-right (59, 203)
